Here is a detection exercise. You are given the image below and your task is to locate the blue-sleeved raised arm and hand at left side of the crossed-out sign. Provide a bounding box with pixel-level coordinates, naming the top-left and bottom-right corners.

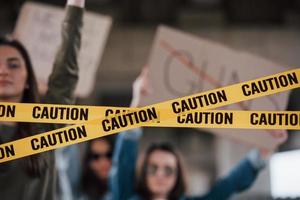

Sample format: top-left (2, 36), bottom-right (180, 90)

top-left (110, 69), bottom-right (149, 200)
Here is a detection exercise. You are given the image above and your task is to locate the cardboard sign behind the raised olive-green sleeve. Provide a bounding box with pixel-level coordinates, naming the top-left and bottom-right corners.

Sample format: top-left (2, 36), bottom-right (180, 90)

top-left (14, 2), bottom-right (112, 97)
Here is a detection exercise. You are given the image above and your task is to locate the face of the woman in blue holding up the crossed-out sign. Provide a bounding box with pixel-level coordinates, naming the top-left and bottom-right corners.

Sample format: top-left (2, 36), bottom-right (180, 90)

top-left (146, 150), bottom-right (177, 198)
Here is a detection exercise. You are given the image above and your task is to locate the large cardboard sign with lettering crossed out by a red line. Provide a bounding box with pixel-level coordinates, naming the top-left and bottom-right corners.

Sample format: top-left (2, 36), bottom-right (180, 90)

top-left (142, 26), bottom-right (288, 148)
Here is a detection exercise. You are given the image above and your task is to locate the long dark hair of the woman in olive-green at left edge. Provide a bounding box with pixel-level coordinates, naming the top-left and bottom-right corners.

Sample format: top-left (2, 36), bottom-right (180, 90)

top-left (0, 38), bottom-right (48, 176)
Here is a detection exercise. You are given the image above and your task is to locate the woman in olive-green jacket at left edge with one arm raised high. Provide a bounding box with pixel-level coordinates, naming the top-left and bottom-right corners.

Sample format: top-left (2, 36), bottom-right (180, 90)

top-left (0, 0), bottom-right (84, 200)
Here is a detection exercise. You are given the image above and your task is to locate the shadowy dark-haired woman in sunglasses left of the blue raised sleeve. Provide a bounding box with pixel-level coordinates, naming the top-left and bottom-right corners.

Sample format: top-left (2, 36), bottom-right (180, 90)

top-left (79, 136), bottom-right (114, 200)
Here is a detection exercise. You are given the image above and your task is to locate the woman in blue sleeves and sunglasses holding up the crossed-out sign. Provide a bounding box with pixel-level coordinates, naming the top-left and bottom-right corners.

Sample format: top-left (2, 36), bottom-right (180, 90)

top-left (110, 69), bottom-right (286, 200)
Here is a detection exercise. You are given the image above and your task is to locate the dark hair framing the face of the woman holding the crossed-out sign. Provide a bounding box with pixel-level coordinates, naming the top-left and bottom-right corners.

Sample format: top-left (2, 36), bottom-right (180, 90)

top-left (136, 142), bottom-right (186, 200)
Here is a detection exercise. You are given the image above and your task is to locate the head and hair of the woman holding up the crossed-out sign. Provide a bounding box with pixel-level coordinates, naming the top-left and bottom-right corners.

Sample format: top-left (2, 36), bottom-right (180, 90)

top-left (136, 143), bottom-right (187, 199)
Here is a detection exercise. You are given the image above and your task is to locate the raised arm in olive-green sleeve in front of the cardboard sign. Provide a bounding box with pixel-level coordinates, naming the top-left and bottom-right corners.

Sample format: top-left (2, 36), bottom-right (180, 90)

top-left (45, 0), bottom-right (85, 104)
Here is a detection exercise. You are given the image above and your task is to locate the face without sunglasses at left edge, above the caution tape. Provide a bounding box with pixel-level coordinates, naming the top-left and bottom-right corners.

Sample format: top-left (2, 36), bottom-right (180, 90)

top-left (0, 45), bottom-right (28, 102)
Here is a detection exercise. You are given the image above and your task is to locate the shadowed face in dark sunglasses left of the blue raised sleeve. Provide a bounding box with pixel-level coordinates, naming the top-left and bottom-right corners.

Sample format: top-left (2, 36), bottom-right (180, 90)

top-left (90, 140), bottom-right (112, 180)
